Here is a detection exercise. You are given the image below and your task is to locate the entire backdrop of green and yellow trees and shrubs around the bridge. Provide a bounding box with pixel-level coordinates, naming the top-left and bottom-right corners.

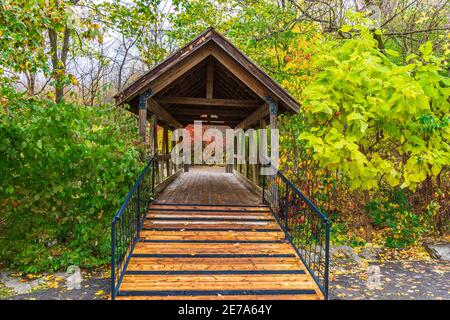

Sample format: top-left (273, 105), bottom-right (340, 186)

top-left (0, 0), bottom-right (450, 271)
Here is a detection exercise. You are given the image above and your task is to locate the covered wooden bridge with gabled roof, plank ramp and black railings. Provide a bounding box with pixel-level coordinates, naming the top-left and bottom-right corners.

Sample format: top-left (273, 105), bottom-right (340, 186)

top-left (111, 28), bottom-right (329, 299)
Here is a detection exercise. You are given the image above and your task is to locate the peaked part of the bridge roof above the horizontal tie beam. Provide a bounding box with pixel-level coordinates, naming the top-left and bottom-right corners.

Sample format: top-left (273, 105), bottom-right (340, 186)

top-left (115, 28), bottom-right (300, 113)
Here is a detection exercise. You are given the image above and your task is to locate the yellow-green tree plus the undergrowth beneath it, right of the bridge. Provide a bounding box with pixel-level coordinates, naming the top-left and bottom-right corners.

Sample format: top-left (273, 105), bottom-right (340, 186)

top-left (281, 23), bottom-right (450, 247)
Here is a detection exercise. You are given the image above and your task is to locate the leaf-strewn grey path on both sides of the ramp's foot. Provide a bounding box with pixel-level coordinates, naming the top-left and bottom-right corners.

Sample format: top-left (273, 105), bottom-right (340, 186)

top-left (0, 260), bottom-right (450, 300)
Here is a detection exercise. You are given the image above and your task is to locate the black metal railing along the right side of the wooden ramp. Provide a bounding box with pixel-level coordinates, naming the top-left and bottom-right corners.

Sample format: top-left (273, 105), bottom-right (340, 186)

top-left (261, 169), bottom-right (330, 299)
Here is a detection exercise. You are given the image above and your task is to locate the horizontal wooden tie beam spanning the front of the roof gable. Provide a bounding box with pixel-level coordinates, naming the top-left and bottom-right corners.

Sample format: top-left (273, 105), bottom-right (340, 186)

top-left (155, 97), bottom-right (260, 108)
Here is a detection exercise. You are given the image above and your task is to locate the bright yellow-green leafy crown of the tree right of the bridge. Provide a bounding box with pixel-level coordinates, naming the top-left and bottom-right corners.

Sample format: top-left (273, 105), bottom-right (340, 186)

top-left (301, 26), bottom-right (450, 190)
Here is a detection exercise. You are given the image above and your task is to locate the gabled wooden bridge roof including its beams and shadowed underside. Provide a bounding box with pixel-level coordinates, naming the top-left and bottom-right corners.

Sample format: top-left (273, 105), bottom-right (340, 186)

top-left (115, 28), bottom-right (299, 127)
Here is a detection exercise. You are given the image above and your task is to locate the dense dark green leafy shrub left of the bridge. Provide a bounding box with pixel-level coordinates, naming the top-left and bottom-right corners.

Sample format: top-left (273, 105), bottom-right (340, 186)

top-left (0, 88), bottom-right (143, 272)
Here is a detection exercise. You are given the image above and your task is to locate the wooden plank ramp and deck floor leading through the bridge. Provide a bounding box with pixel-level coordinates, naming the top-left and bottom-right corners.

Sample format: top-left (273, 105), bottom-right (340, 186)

top-left (117, 170), bottom-right (323, 300)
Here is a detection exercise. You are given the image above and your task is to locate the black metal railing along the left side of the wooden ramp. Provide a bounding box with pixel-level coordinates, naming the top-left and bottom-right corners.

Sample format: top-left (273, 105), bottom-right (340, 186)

top-left (111, 155), bottom-right (158, 300)
